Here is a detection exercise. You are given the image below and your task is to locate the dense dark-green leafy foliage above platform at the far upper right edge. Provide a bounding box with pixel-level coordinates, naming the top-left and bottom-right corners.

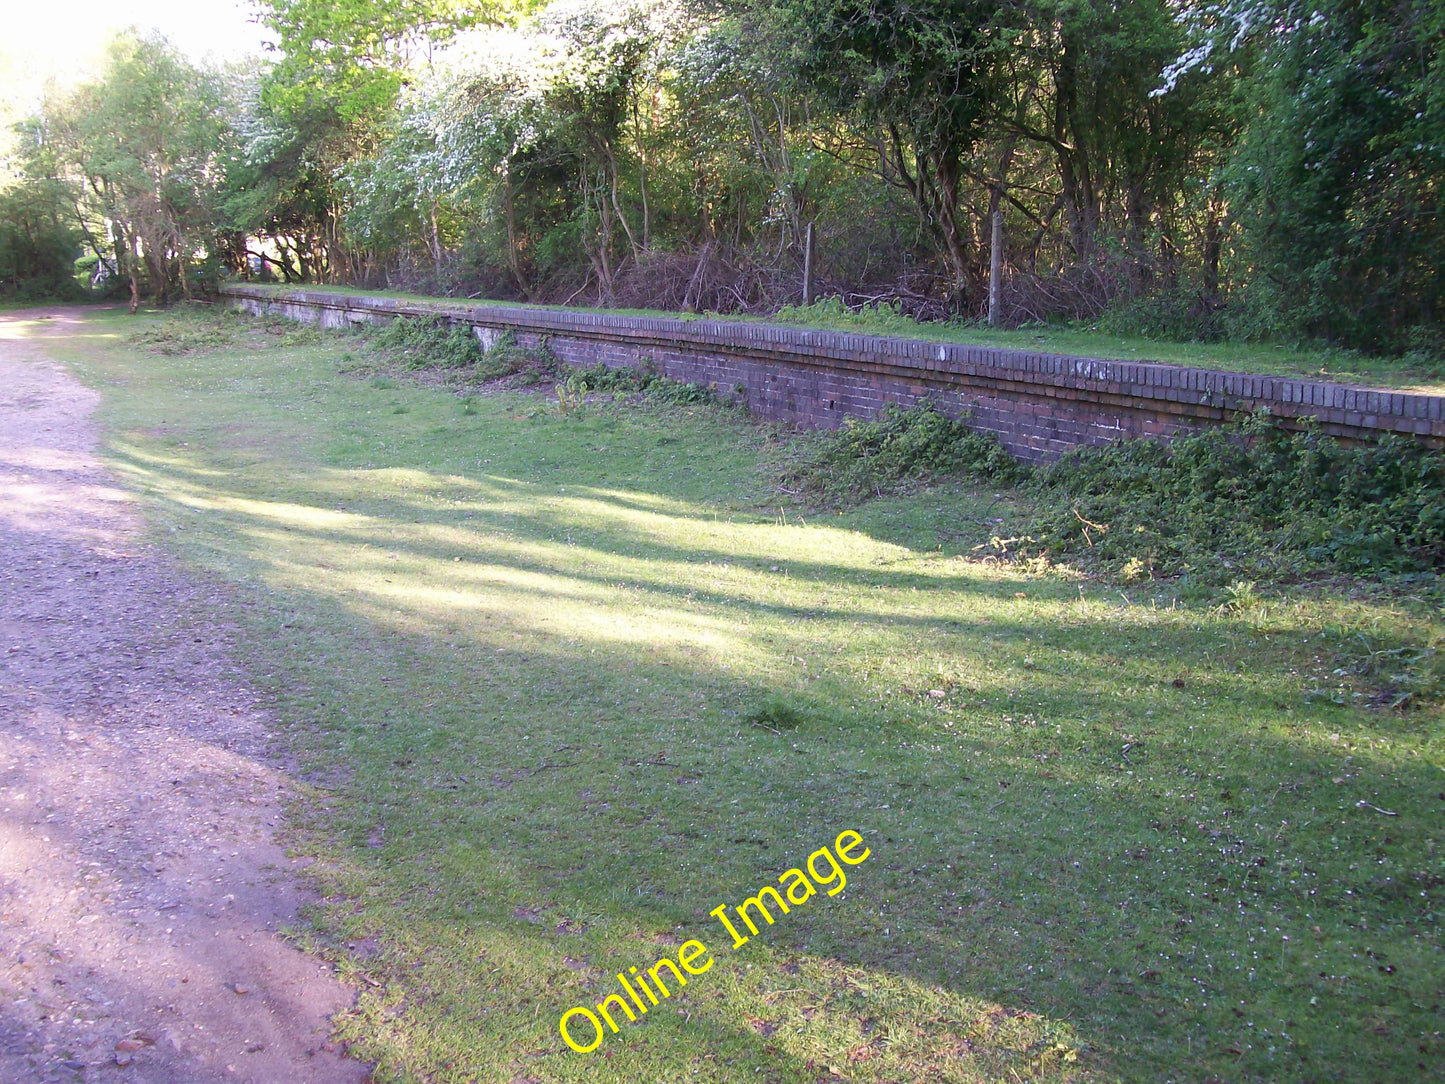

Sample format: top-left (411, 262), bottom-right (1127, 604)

top-left (1230, 0), bottom-right (1445, 354)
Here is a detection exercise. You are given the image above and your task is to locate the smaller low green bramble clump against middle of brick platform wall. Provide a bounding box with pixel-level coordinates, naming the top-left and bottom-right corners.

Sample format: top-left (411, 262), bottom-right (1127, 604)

top-left (783, 403), bottom-right (1025, 506)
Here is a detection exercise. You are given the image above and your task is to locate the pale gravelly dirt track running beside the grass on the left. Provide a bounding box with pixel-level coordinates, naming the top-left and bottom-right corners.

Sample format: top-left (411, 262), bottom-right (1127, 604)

top-left (0, 309), bottom-right (367, 1084)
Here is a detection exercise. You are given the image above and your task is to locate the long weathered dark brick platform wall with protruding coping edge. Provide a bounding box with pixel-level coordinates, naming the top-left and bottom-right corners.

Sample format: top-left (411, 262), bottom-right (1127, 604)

top-left (221, 285), bottom-right (1445, 463)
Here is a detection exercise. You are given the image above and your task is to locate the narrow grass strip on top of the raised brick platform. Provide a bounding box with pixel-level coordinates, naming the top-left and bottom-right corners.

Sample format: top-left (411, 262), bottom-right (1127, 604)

top-left (236, 286), bottom-right (1445, 395)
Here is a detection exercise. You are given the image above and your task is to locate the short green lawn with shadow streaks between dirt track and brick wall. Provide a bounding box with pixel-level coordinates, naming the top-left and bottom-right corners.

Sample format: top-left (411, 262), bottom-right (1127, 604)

top-left (36, 314), bottom-right (1445, 1084)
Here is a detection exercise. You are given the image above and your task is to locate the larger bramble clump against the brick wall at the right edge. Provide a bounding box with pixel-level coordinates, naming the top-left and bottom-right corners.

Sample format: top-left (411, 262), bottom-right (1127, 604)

top-left (1030, 418), bottom-right (1445, 584)
